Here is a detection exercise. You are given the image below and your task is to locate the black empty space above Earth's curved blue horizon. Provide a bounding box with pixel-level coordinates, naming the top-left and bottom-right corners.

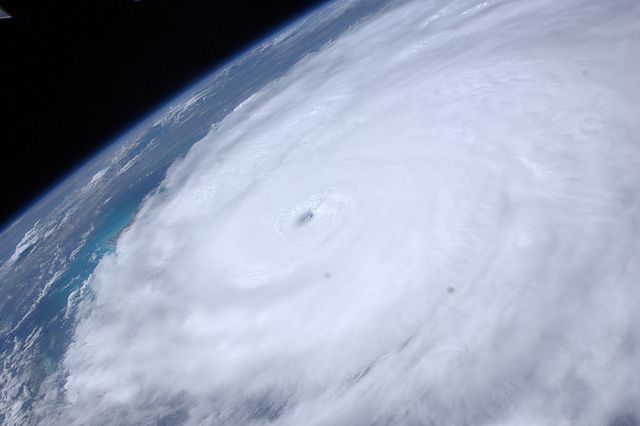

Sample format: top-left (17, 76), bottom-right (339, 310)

top-left (0, 0), bottom-right (320, 224)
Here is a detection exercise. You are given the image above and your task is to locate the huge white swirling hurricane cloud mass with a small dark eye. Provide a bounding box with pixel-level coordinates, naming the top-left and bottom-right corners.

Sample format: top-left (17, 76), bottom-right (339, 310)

top-left (40, 0), bottom-right (640, 425)
